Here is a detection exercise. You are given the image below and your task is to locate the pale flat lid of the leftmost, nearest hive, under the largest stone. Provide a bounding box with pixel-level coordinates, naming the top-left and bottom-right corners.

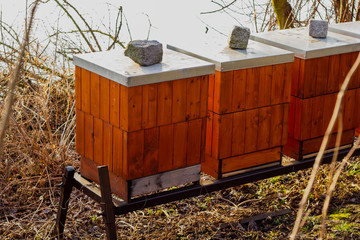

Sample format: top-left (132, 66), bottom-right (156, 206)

top-left (74, 49), bottom-right (215, 87)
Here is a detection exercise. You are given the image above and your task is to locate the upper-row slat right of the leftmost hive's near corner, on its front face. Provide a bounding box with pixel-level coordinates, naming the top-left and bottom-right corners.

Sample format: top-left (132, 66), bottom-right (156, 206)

top-left (127, 86), bottom-right (143, 132)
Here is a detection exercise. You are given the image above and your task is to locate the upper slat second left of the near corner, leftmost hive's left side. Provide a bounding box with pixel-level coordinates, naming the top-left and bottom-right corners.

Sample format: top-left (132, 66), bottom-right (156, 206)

top-left (110, 81), bottom-right (121, 127)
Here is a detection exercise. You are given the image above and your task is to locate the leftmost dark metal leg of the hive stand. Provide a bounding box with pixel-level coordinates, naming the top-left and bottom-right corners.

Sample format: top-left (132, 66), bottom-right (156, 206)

top-left (53, 166), bottom-right (75, 239)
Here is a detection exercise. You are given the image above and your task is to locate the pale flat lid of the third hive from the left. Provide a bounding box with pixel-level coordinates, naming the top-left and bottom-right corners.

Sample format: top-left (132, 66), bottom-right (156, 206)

top-left (251, 28), bottom-right (360, 59)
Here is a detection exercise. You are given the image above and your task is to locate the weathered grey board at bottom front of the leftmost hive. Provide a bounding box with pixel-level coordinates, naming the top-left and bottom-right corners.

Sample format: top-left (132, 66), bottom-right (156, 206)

top-left (131, 164), bottom-right (200, 197)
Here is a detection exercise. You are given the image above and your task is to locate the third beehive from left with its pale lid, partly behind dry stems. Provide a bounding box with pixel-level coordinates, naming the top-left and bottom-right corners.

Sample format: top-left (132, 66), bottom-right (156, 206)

top-left (252, 28), bottom-right (360, 160)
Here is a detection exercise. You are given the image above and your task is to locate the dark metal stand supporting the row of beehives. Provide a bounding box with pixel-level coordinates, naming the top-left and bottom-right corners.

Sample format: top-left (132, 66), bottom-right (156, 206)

top-left (54, 148), bottom-right (360, 240)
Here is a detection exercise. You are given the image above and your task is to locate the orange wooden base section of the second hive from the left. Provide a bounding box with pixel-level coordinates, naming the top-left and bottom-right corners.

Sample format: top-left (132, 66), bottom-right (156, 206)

top-left (201, 147), bottom-right (282, 179)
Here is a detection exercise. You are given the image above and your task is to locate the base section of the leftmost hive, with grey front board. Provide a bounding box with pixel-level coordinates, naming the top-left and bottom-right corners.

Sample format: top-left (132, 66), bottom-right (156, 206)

top-left (80, 157), bottom-right (200, 202)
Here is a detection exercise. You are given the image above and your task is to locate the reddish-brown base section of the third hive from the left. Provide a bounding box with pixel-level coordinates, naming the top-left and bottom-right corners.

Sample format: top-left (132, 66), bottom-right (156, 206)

top-left (283, 129), bottom-right (354, 161)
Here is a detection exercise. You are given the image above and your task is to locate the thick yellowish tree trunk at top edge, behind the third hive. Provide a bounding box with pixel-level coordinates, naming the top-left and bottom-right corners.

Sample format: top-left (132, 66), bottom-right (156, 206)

top-left (272, 0), bottom-right (295, 29)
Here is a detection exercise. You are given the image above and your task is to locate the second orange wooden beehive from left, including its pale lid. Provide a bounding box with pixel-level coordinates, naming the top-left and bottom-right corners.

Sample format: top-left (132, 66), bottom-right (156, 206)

top-left (168, 38), bottom-right (294, 178)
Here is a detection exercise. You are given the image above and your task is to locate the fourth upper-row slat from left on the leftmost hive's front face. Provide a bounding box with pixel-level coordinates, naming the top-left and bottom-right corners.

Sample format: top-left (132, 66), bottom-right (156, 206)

top-left (172, 79), bottom-right (187, 123)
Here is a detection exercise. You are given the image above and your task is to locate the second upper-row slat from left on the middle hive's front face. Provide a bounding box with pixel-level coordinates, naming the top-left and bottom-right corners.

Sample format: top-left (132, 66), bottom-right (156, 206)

top-left (231, 69), bottom-right (246, 112)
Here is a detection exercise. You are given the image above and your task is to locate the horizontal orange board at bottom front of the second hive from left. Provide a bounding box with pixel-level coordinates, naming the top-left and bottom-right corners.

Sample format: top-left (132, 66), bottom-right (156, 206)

top-left (222, 147), bottom-right (281, 173)
